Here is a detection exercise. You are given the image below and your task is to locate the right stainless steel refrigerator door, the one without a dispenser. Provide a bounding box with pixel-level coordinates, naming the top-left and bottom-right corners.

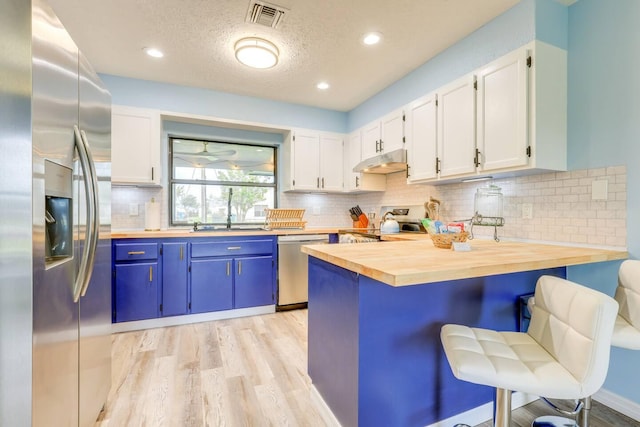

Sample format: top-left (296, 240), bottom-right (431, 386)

top-left (78, 53), bottom-right (111, 427)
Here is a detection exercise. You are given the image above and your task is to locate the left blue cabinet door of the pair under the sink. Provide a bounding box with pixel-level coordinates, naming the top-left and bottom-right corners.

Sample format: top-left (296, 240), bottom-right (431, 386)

top-left (191, 258), bottom-right (233, 313)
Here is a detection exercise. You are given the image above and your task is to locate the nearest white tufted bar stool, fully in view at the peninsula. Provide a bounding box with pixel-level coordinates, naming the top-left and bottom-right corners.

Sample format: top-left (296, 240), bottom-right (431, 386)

top-left (440, 276), bottom-right (618, 427)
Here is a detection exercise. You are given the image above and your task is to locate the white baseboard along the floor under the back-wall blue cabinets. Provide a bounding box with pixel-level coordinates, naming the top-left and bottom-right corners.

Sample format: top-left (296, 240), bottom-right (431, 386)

top-left (111, 305), bottom-right (276, 334)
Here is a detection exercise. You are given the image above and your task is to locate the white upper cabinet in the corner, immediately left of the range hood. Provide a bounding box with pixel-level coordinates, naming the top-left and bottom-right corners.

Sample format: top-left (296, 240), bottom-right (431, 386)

top-left (344, 130), bottom-right (387, 193)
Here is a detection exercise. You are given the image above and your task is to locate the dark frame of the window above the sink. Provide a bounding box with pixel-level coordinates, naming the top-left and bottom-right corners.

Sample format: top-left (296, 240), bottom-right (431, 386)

top-left (167, 135), bottom-right (280, 227)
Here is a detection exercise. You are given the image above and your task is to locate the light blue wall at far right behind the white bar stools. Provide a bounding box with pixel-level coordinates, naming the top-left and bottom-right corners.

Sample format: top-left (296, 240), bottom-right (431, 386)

top-left (568, 0), bottom-right (640, 403)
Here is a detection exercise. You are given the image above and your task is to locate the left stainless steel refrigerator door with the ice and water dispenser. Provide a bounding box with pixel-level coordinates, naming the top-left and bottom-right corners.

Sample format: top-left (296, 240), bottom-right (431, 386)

top-left (32, 0), bottom-right (78, 426)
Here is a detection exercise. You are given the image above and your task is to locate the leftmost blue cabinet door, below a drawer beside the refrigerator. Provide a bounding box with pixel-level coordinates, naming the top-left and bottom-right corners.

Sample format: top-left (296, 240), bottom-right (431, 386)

top-left (115, 262), bottom-right (159, 322)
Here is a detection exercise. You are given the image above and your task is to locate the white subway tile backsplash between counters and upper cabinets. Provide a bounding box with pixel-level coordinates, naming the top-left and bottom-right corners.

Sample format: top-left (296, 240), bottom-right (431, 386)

top-left (112, 166), bottom-right (627, 247)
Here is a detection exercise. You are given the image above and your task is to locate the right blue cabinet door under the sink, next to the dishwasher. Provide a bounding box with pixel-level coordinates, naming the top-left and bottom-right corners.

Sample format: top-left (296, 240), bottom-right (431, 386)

top-left (234, 256), bottom-right (274, 308)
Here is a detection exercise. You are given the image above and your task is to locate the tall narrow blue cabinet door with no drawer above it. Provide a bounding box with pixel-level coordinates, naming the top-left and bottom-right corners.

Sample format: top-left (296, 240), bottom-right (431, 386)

top-left (161, 242), bottom-right (188, 316)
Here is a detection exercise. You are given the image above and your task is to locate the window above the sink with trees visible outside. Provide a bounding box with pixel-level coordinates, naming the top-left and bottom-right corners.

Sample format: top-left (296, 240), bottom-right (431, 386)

top-left (169, 137), bottom-right (277, 226)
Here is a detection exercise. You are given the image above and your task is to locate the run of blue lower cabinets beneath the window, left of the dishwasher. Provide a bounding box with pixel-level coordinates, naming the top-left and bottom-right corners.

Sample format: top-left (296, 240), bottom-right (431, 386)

top-left (112, 236), bottom-right (277, 322)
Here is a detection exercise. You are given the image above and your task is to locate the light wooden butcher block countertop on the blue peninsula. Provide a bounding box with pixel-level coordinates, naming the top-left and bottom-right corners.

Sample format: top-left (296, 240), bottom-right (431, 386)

top-left (302, 240), bottom-right (628, 286)
